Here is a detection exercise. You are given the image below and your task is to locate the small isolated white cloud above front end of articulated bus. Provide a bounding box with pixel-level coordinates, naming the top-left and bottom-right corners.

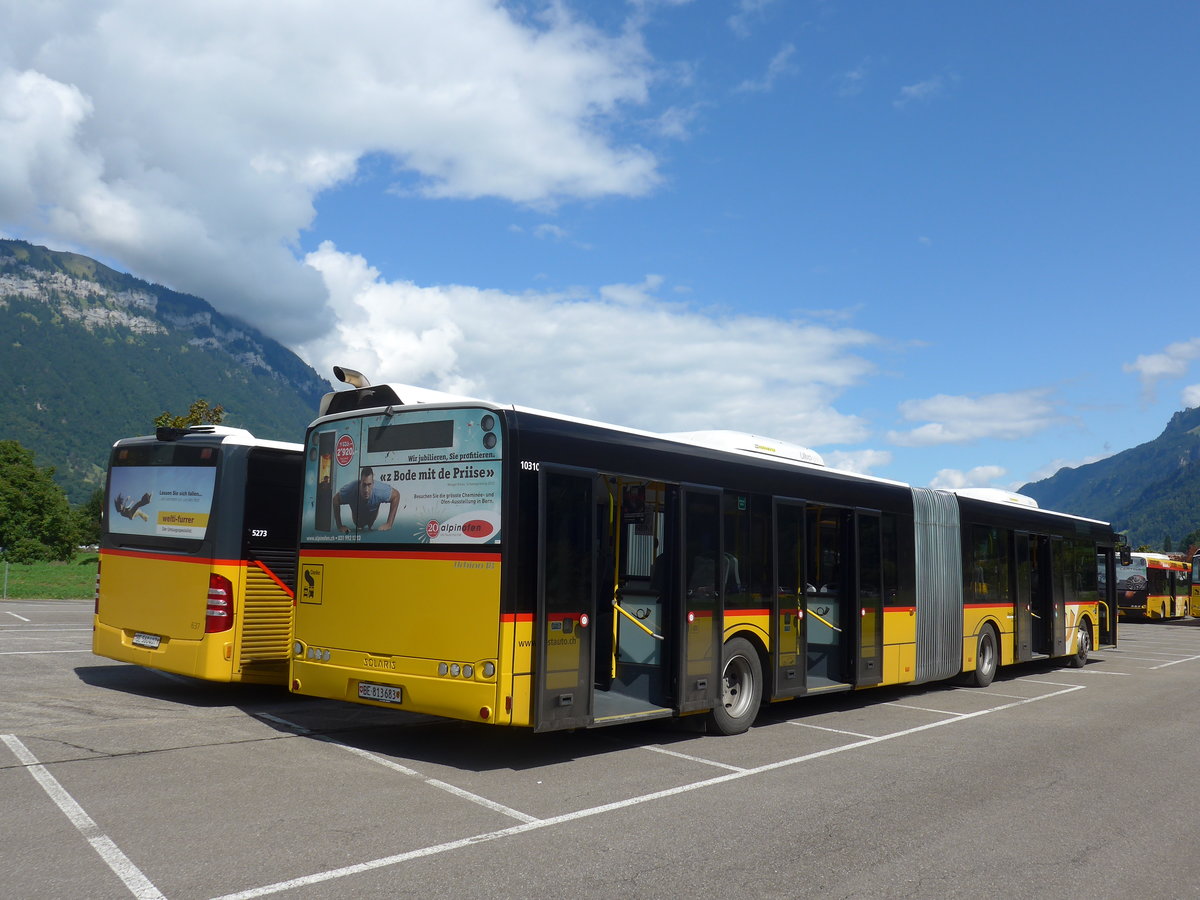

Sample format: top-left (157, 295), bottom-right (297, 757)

top-left (888, 389), bottom-right (1063, 446)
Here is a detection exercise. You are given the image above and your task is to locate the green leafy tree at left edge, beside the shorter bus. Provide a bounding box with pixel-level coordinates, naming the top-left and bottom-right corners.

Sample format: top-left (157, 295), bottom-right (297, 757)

top-left (0, 440), bottom-right (77, 563)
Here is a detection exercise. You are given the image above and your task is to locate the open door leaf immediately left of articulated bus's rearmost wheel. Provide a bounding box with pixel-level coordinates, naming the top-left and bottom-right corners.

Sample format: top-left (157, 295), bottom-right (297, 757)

top-left (674, 485), bottom-right (715, 713)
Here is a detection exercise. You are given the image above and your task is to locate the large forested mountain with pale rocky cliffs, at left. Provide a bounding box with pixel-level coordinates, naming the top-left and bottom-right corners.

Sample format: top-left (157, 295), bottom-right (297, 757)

top-left (0, 240), bottom-right (331, 503)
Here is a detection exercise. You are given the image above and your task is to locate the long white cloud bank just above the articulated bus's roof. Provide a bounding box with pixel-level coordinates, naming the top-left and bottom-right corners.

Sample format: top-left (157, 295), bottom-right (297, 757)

top-left (299, 242), bottom-right (882, 448)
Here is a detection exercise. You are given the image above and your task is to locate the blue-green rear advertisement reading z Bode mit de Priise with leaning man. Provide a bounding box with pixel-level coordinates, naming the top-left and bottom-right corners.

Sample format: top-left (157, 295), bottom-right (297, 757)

top-left (304, 409), bottom-right (503, 544)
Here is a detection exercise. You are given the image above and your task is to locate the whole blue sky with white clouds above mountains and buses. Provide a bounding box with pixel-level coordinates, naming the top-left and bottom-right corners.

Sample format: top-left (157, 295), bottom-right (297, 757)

top-left (0, 0), bottom-right (1200, 487)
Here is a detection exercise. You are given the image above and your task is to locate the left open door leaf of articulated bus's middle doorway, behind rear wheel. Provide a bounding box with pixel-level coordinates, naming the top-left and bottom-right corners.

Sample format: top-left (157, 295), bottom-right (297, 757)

top-left (770, 498), bottom-right (808, 697)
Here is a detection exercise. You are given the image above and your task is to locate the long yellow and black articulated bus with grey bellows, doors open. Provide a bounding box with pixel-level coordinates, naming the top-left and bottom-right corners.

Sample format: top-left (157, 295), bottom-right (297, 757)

top-left (292, 370), bottom-right (1116, 734)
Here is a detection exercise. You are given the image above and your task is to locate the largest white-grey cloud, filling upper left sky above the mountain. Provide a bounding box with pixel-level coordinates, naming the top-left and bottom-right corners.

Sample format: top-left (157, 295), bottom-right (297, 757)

top-left (0, 0), bottom-right (659, 341)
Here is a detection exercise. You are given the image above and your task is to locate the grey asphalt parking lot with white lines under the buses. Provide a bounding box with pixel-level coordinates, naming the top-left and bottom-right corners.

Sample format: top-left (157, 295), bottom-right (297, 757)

top-left (7, 601), bottom-right (1200, 899)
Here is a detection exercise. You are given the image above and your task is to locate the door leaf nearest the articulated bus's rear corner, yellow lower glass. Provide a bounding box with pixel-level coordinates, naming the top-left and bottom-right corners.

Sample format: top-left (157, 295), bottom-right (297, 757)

top-left (534, 463), bottom-right (595, 731)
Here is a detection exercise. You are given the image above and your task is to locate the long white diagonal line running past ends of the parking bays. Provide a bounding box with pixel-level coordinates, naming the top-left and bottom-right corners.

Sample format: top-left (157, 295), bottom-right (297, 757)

top-left (214, 682), bottom-right (1086, 900)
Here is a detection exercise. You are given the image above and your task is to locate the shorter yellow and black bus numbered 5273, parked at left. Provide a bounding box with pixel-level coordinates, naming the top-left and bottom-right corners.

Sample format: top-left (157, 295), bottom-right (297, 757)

top-left (92, 426), bottom-right (304, 685)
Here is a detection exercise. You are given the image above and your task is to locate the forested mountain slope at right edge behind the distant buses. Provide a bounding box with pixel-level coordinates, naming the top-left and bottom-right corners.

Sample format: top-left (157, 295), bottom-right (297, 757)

top-left (1021, 408), bottom-right (1200, 551)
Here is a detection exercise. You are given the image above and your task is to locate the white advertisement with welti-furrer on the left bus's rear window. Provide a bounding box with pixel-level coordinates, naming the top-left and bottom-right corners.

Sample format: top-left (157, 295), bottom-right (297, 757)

top-left (108, 466), bottom-right (217, 540)
